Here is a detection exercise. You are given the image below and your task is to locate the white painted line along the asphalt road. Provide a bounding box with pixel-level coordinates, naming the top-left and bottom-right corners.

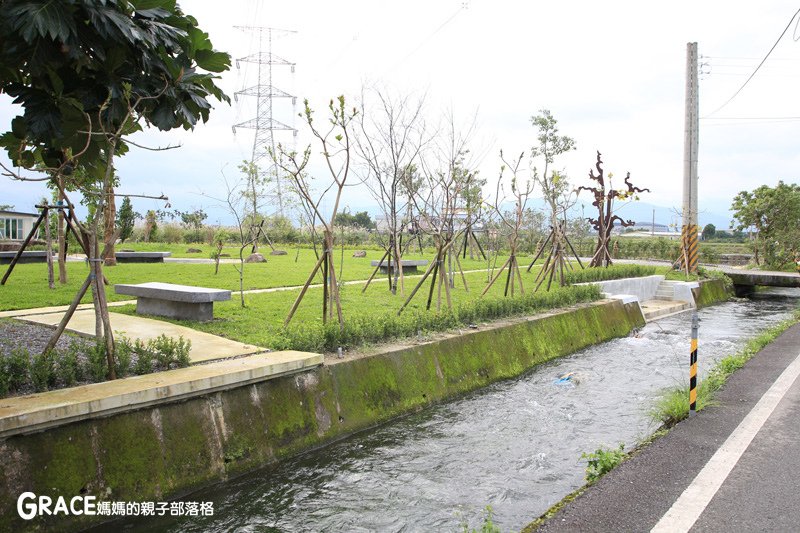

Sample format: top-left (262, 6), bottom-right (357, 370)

top-left (651, 354), bottom-right (800, 533)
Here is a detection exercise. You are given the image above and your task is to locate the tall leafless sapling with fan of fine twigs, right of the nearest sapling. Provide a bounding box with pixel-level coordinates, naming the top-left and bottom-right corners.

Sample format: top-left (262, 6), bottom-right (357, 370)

top-left (354, 89), bottom-right (426, 295)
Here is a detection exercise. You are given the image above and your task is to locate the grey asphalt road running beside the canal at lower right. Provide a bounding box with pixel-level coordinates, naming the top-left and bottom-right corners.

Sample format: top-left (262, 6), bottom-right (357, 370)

top-left (538, 324), bottom-right (800, 532)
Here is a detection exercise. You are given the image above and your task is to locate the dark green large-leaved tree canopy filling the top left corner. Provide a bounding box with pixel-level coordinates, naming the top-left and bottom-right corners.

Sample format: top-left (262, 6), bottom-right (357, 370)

top-left (0, 0), bottom-right (230, 179)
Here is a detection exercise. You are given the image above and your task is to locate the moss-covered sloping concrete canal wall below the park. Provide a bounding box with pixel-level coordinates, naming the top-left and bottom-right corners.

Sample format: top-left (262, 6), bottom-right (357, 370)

top-left (0, 301), bottom-right (644, 530)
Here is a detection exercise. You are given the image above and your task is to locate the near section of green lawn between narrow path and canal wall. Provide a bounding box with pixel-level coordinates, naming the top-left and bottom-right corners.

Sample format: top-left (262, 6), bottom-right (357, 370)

top-left (114, 270), bottom-right (599, 350)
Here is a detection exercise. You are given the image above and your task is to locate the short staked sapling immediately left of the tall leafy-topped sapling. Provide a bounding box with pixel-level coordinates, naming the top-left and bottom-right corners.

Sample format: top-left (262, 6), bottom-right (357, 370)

top-left (481, 150), bottom-right (534, 297)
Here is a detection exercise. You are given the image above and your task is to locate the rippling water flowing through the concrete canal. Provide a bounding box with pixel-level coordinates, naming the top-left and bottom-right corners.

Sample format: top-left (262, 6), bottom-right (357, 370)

top-left (126, 289), bottom-right (800, 532)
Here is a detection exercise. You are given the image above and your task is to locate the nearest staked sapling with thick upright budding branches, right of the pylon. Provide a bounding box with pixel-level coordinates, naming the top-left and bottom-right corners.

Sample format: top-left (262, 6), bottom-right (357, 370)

top-left (271, 96), bottom-right (358, 329)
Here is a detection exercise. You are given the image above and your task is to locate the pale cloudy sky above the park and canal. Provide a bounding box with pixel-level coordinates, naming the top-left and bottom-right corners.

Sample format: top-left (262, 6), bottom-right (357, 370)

top-left (0, 0), bottom-right (800, 224)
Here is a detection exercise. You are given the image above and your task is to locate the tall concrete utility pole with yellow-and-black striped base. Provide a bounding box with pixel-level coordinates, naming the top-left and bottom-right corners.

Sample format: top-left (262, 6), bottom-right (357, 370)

top-left (681, 43), bottom-right (700, 274)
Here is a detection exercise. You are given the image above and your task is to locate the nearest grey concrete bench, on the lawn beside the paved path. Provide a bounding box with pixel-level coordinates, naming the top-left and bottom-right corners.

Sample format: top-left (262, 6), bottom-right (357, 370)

top-left (114, 281), bottom-right (231, 322)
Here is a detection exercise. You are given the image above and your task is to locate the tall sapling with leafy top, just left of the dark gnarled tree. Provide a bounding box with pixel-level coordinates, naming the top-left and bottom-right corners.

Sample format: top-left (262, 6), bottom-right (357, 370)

top-left (528, 109), bottom-right (583, 291)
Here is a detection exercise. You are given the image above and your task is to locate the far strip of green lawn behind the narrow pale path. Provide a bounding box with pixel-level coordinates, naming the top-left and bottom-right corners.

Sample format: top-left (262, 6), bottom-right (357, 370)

top-left (0, 248), bottom-right (505, 311)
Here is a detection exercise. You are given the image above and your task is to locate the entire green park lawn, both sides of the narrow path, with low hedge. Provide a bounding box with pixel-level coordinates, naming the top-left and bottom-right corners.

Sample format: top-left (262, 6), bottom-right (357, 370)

top-left (0, 244), bottom-right (708, 351)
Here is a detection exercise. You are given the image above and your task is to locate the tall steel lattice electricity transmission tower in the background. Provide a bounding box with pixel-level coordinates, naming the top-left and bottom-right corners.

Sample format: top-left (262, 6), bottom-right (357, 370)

top-left (233, 26), bottom-right (297, 217)
